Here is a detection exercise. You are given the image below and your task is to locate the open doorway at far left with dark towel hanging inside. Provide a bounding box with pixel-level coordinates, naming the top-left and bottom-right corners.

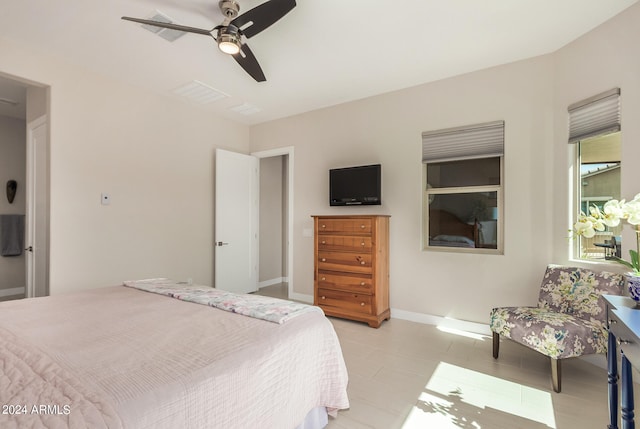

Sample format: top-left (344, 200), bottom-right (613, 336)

top-left (0, 73), bottom-right (49, 301)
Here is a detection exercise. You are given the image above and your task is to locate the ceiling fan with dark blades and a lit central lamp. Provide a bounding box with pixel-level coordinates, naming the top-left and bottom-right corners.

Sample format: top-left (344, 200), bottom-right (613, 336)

top-left (122, 0), bottom-right (296, 82)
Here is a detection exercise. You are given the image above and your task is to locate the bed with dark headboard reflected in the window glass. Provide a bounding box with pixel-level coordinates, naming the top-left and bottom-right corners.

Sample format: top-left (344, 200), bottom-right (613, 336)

top-left (429, 209), bottom-right (479, 248)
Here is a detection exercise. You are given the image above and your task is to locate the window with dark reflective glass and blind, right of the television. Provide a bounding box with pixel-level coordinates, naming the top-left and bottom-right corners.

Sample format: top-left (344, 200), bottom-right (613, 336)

top-left (422, 121), bottom-right (504, 253)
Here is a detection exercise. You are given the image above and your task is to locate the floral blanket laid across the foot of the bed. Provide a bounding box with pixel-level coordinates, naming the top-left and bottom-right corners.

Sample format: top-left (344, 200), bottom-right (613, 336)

top-left (124, 278), bottom-right (322, 324)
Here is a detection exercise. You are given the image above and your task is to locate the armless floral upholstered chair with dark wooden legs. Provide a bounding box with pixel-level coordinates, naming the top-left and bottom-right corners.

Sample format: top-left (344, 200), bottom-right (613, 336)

top-left (490, 265), bottom-right (624, 392)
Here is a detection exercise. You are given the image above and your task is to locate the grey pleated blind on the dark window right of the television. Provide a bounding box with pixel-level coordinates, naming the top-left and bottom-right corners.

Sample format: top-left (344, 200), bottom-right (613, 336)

top-left (422, 121), bottom-right (504, 163)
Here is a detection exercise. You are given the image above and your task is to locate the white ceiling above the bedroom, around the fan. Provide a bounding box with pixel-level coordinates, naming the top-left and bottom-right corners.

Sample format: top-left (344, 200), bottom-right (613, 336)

top-left (0, 0), bottom-right (637, 124)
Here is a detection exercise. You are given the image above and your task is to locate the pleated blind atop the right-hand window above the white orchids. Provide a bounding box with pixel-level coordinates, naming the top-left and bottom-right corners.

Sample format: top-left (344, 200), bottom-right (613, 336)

top-left (569, 88), bottom-right (621, 143)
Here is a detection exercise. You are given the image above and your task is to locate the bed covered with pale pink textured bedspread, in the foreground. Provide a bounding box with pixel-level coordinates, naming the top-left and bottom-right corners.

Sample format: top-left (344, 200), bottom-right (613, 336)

top-left (0, 280), bottom-right (349, 429)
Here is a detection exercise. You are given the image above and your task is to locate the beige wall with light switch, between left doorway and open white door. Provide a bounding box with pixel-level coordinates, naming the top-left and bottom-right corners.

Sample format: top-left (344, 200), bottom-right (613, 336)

top-left (0, 39), bottom-right (249, 295)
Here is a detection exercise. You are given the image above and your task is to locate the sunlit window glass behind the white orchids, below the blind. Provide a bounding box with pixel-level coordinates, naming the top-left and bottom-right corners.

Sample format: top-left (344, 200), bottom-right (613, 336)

top-left (576, 132), bottom-right (622, 259)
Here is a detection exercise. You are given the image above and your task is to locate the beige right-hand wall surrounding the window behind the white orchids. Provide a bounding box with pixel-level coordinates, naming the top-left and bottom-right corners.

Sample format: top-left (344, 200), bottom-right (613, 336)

top-left (545, 4), bottom-right (640, 272)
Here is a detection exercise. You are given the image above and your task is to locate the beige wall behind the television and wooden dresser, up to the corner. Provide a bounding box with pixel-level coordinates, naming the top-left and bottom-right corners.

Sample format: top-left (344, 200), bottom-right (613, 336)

top-left (251, 56), bottom-right (554, 322)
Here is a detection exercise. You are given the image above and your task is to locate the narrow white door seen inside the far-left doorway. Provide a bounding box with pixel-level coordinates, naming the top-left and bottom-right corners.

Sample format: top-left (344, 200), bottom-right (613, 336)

top-left (25, 116), bottom-right (49, 298)
